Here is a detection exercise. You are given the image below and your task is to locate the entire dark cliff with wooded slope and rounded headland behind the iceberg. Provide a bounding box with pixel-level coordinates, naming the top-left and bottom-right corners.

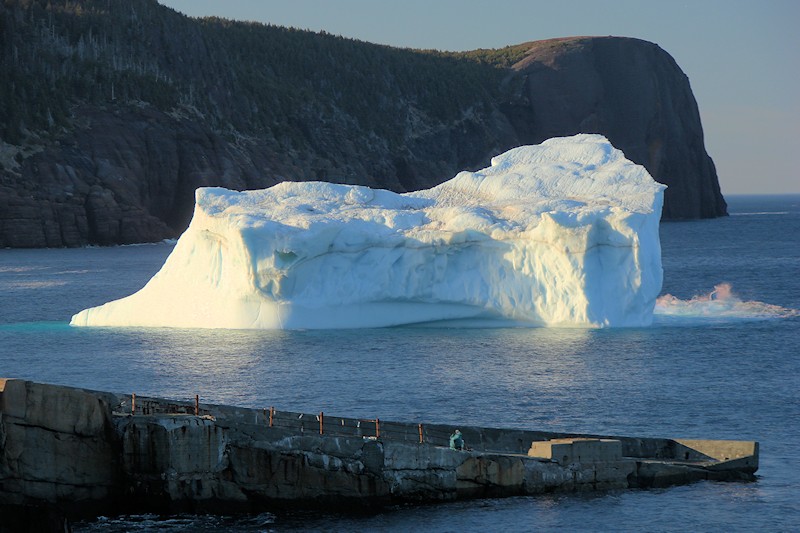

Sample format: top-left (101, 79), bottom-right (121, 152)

top-left (0, 0), bottom-right (726, 247)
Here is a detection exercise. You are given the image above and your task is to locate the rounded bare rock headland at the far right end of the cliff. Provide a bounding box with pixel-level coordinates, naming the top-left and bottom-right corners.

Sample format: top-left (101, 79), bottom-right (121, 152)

top-left (511, 37), bottom-right (726, 219)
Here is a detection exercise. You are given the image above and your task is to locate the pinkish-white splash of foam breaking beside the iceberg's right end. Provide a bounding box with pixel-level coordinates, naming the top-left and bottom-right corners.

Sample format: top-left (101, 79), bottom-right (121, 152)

top-left (655, 283), bottom-right (800, 320)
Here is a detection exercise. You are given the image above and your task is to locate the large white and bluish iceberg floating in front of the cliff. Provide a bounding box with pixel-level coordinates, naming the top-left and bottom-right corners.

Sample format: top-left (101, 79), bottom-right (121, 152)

top-left (71, 134), bottom-right (665, 329)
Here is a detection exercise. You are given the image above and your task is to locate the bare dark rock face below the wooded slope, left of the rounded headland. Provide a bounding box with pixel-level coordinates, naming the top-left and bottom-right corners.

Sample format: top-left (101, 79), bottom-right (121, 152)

top-left (0, 102), bottom-right (513, 248)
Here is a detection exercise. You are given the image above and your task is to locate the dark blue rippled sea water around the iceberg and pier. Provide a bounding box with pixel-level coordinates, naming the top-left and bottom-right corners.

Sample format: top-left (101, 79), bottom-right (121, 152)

top-left (0, 195), bottom-right (800, 531)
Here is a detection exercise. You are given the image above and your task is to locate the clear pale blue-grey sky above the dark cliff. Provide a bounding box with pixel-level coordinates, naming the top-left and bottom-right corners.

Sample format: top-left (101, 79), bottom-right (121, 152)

top-left (160, 0), bottom-right (800, 195)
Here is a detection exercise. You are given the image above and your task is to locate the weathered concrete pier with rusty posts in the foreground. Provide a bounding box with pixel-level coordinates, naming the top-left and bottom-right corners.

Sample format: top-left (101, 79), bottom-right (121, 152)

top-left (0, 379), bottom-right (758, 531)
